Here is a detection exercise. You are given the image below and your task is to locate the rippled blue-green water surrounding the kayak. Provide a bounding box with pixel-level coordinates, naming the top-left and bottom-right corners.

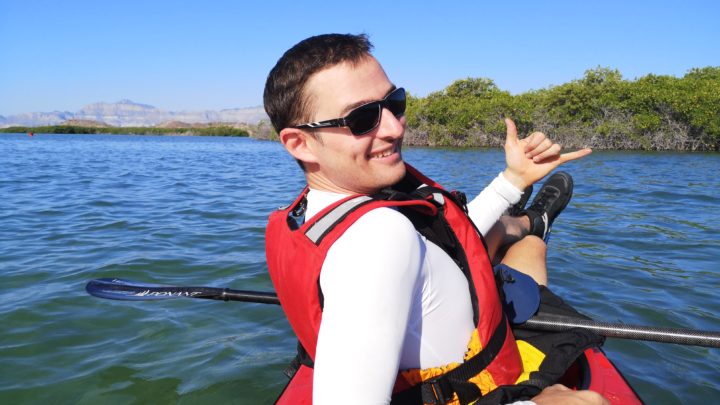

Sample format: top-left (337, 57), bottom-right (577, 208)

top-left (0, 135), bottom-right (720, 404)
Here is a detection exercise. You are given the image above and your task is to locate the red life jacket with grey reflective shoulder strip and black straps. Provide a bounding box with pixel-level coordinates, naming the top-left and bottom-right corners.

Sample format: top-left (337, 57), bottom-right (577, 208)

top-left (265, 165), bottom-right (522, 404)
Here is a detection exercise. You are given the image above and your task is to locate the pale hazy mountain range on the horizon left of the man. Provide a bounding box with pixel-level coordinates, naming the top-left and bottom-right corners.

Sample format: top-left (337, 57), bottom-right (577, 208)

top-left (0, 100), bottom-right (268, 128)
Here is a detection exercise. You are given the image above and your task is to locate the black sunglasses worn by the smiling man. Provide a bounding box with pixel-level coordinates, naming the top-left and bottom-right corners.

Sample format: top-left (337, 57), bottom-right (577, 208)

top-left (293, 87), bottom-right (405, 135)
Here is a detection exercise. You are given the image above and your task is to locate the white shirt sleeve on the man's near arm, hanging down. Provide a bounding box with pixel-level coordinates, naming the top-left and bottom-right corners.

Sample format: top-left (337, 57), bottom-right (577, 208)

top-left (313, 208), bottom-right (424, 405)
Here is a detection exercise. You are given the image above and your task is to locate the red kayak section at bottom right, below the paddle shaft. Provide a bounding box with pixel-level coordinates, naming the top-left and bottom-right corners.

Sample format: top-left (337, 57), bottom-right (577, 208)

top-left (560, 347), bottom-right (643, 405)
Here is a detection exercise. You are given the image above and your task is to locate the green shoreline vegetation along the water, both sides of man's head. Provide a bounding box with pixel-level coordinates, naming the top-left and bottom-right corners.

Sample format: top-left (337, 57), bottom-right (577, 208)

top-left (0, 67), bottom-right (720, 151)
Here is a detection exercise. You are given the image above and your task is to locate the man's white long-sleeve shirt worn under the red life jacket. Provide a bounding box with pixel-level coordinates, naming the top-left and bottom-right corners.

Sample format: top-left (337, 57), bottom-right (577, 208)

top-left (306, 175), bottom-right (522, 404)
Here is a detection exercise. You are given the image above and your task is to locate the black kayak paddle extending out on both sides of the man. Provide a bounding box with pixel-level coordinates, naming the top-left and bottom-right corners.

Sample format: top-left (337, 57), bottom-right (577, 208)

top-left (85, 278), bottom-right (720, 348)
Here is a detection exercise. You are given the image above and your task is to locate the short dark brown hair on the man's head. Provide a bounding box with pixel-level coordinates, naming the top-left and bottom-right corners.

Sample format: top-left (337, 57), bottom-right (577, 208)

top-left (263, 34), bottom-right (372, 133)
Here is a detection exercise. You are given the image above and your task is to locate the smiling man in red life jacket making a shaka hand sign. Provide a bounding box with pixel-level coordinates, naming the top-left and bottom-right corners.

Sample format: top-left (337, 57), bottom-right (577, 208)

top-left (264, 34), bottom-right (602, 404)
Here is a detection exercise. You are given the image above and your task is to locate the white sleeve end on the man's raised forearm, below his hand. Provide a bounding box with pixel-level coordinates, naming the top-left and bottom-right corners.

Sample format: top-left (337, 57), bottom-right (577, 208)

top-left (467, 173), bottom-right (523, 236)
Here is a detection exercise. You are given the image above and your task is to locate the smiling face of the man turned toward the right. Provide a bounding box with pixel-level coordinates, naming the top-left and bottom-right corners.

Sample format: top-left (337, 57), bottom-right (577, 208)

top-left (298, 57), bottom-right (405, 194)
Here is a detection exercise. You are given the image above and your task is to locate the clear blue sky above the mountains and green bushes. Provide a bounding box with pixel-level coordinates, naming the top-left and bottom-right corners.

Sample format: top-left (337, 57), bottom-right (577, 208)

top-left (0, 0), bottom-right (720, 116)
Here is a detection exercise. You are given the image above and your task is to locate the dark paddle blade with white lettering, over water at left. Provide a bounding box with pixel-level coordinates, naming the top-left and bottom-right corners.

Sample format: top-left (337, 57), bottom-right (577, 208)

top-left (85, 278), bottom-right (222, 301)
